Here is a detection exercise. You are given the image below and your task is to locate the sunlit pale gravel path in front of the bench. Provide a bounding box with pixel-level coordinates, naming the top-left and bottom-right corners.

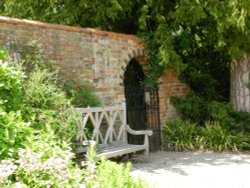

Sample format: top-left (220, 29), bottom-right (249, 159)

top-left (131, 152), bottom-right (250, 188)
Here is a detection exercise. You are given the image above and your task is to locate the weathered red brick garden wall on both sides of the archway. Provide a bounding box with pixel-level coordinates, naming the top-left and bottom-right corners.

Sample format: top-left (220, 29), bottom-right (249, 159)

top-left (0, 17), bottom-right (188, 127)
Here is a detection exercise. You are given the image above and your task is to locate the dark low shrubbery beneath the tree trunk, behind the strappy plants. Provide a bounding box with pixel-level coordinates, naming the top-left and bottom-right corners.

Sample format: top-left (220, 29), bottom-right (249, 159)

top-left (171, 95), bottom-right (250, 133)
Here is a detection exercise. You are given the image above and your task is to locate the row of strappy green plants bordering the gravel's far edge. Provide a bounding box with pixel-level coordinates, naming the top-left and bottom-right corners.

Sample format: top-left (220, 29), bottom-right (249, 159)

top-left (163, 120), bottom-right (250, 152)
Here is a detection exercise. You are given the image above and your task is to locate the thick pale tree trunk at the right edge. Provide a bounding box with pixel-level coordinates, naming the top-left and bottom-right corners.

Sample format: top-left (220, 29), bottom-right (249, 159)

top-left (230, 55), bottom-right (250, 112)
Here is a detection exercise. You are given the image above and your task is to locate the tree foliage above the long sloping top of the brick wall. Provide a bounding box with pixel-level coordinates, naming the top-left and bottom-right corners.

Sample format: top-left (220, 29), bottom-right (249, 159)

top-left (0, 0), bottom-right (136, 30)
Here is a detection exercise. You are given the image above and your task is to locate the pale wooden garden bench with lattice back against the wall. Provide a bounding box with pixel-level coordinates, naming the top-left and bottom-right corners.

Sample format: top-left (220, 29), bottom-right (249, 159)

top-left (76, 102), bottom-right (153, 158)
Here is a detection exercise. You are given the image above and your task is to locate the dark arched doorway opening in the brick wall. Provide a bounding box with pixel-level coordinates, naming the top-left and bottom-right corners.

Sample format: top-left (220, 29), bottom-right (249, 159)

top-left (124, 59), bottom-right (147, 144)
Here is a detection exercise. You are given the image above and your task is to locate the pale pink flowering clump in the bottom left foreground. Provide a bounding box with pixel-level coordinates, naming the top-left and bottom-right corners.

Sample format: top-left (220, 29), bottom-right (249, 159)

top-left (9, 150), bottom-right (83, 187)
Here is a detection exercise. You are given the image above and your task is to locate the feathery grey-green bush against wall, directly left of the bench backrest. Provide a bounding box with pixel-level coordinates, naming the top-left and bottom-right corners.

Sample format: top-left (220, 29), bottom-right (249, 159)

top-left (22, 69), bottom-right (77, 142)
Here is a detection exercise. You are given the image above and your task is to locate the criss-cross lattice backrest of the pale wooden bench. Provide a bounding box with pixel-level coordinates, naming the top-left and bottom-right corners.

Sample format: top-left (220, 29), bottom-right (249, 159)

top-left (76, 102), bottom-right (127, 145)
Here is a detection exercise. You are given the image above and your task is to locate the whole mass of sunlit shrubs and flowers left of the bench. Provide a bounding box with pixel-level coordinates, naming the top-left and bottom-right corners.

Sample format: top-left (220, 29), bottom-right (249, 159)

top-left (0, 47), bottom-right (145, 188)
